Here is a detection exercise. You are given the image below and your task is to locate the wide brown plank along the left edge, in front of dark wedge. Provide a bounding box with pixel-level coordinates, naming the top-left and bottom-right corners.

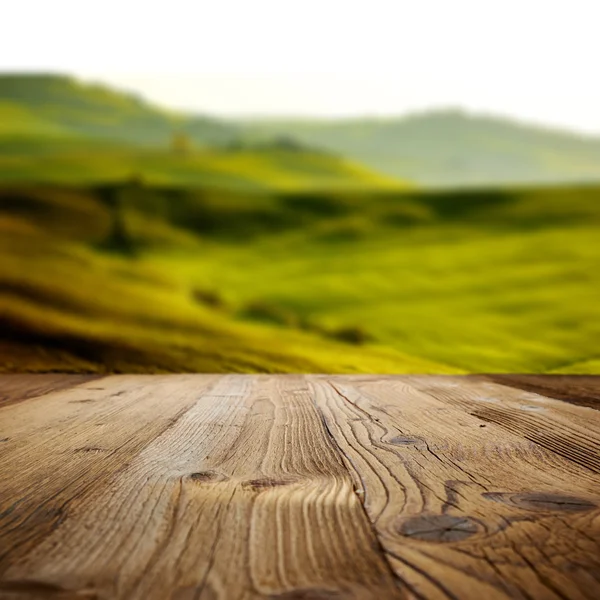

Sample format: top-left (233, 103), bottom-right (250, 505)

top-left (0, 375), bottom-right (215, 575)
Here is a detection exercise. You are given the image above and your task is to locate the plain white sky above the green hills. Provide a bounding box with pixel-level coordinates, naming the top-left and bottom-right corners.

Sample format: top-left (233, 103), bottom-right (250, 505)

top-left (0, 0), bottom-right (600, 133)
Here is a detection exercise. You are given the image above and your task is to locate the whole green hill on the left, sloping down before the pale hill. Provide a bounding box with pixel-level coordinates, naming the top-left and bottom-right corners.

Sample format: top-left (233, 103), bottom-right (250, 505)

top-left (0, 75), bottom-right (403, 190)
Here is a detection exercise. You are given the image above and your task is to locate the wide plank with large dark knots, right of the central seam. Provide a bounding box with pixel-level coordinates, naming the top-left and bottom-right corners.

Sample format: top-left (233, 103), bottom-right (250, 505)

top-left (311, 376), bottom-right (600, 600)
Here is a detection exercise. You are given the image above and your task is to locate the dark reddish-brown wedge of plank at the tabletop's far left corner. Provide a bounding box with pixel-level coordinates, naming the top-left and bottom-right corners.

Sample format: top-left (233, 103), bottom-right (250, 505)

top-left (0, 373), bottom-right (101, 408)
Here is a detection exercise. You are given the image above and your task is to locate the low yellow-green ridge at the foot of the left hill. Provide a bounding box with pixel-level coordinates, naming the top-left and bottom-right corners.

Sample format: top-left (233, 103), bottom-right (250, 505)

top-left (0, 138), bottom-right (407, 190)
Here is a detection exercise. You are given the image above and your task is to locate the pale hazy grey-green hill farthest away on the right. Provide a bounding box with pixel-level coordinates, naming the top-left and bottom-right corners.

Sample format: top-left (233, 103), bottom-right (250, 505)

top-left (243, 110), bottom-right (600, 187)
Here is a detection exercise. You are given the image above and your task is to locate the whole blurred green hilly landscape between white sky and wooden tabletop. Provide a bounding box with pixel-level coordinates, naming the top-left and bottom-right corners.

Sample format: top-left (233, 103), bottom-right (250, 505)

top-left (0, 74), bottom-right (600, 373)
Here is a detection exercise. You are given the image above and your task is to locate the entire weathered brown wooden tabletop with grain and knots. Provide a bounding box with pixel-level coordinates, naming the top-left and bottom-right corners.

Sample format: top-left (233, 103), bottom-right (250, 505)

top-left (0, 375), bottom-right (600, 600)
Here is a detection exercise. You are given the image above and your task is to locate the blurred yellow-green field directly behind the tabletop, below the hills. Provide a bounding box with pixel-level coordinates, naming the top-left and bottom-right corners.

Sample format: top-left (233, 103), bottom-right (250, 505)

top-left (0, 181), bottom-right (600, 373)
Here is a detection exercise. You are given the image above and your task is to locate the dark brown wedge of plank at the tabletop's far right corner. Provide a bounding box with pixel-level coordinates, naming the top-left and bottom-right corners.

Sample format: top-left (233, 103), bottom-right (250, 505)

top-left (473, 374), bottom-right (600, 410)
